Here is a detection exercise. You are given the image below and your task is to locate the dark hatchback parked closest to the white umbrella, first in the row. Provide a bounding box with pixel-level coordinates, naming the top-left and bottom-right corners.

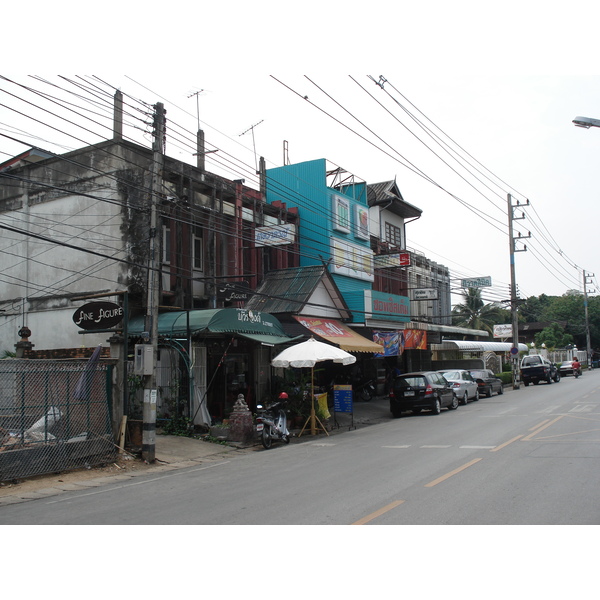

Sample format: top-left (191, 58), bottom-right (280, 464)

top-left (390, 371), bottom-right (458, 418)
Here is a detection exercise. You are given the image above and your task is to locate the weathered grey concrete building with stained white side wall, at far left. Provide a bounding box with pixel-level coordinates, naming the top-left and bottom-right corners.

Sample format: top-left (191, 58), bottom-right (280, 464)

top-left (0, 93), bottom-right (298, 426)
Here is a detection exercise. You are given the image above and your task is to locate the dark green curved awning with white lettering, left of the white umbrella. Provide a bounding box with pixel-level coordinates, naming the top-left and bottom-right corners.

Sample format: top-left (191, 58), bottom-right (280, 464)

top-left (129, 308), bottom-right (298, 346)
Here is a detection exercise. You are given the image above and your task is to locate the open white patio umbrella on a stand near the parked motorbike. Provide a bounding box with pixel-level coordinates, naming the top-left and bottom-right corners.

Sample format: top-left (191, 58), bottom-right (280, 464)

top-left (271, 337), bottom-right (356, 435)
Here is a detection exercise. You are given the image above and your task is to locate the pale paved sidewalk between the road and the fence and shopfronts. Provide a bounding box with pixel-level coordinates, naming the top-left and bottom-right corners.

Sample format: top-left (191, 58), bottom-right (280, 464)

top-left (0, 396), bottom-right (391, 508)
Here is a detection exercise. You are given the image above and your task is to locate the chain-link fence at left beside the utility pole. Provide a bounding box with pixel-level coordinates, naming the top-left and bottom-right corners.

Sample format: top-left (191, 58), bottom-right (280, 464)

top-left (0, 359), bottom-right (115, 481)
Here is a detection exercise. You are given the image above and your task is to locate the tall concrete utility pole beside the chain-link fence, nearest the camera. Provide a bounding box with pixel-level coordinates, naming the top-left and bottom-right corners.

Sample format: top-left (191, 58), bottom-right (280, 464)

top-left (142, 102), bottom-right (166, 462)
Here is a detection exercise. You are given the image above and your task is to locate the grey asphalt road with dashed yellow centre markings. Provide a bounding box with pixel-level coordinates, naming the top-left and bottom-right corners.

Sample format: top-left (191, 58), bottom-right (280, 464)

top-left (0, 371), bottom-right (600, 525)
